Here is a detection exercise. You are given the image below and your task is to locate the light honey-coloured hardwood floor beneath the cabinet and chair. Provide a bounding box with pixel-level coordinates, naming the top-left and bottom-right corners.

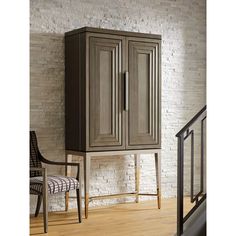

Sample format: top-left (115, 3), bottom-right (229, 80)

top-left (30, 199), bottom-right (192, 236)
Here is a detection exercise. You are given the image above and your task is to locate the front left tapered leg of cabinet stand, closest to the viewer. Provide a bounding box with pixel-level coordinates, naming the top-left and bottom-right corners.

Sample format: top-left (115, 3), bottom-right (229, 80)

top-left (83, 154), bottom-right (91, 219)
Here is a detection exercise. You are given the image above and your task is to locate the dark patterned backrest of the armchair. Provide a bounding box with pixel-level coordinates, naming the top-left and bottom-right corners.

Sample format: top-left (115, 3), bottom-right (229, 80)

top-left (30, 131), bottom-right (42, 177)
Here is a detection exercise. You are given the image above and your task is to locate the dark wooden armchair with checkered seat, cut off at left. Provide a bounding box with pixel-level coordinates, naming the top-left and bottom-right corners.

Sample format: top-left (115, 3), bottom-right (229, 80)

top-left (30, 131), bottom-right (82, 233)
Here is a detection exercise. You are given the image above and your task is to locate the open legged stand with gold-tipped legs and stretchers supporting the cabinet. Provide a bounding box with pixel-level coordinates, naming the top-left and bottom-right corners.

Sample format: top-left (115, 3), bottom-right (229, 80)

top-left (65, 149), bottom-right (161, 219)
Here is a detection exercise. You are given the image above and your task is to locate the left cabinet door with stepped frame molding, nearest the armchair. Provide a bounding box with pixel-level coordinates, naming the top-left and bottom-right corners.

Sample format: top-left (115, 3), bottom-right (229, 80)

top-left (89, 35), bottom-right (125, 150)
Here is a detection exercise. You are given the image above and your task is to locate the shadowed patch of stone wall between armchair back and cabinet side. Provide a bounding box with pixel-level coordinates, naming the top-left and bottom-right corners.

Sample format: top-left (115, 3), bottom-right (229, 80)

top-left (30, 33), bottom-right (65, 173)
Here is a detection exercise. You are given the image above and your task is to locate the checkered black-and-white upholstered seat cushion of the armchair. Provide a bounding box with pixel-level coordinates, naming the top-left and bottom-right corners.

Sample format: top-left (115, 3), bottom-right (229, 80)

top-left (30, 175), bottom-right (79, 195)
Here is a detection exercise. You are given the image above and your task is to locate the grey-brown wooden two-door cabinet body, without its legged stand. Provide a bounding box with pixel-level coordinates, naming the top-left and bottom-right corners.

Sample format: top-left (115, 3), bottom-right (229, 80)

top-left (65, 27), bottom-right (161, 152)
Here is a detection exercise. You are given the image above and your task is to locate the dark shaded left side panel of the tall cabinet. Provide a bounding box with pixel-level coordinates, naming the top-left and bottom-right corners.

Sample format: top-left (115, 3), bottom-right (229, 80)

top-left (65, 35), bottom-right (81, 150)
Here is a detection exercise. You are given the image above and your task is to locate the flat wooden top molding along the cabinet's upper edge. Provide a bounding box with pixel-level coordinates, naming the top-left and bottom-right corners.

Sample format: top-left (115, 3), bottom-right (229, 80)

top-left (65, 27), bottom-right (161, 39)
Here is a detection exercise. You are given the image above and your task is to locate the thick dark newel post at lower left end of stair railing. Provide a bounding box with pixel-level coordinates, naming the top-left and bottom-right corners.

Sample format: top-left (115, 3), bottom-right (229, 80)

top-left (177, 134), bottom-right (184, 236)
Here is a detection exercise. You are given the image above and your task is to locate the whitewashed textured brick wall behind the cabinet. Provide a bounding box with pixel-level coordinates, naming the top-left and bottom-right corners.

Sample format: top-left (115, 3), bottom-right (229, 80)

top-left (30, 0), bottom-right (206, 212)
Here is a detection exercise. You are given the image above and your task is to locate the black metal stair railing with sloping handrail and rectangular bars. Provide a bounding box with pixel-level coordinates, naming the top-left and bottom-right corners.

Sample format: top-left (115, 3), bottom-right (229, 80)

top-left (176, 106), bottom-right (206, 236)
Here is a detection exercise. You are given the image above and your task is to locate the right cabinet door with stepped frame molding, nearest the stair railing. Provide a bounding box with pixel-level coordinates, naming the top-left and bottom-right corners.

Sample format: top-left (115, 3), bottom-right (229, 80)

top-left (127, 38), bottom-right (161, 149)
